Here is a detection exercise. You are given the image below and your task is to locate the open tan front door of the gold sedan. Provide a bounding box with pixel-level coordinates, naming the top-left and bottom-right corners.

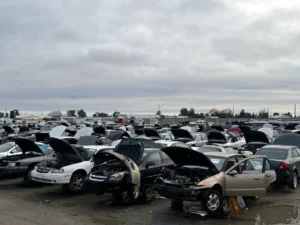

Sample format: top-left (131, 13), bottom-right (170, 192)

top-left (225, 157), bottom-right (266, 196)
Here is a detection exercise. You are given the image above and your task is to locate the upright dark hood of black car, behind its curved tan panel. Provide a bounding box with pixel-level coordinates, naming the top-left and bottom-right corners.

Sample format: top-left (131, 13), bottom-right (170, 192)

top-left (114, 138), bottom-right (144, 163)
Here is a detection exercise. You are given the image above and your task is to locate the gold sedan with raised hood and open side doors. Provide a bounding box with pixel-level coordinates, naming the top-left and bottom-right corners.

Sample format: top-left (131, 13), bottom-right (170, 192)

top-left (155, 147), bottom-right (276, 216)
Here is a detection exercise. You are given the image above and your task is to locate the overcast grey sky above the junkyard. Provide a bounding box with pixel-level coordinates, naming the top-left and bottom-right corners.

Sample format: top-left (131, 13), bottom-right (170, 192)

top-left (0, 0), bottom-right (300, 116)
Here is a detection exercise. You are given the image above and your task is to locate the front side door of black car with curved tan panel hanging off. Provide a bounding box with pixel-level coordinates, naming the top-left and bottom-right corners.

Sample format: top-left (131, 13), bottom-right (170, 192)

top-left (141, 151), bottom-right (163, 186)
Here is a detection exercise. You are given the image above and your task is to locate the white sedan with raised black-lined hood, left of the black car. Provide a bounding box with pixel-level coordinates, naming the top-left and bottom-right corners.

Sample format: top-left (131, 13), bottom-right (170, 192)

top-left (31, 138), bottom-right (101, 193)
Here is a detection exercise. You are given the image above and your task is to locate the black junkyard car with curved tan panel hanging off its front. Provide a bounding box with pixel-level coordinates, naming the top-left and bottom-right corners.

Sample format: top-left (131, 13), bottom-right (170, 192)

top-left (87, 138), bottom-right (173, 202)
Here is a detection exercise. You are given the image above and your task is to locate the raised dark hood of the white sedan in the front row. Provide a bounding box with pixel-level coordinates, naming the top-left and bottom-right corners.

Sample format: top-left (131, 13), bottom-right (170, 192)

top-left (48, 137), bottom-right (88, 161)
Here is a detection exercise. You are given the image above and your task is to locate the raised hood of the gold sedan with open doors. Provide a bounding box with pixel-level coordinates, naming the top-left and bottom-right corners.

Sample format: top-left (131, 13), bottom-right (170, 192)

top-left (161, 146), bottom-right (218, 173)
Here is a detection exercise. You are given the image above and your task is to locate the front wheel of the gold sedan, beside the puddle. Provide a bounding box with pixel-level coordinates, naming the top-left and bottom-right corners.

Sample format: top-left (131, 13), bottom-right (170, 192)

top-left (201, 190), bottom-right (224, 217)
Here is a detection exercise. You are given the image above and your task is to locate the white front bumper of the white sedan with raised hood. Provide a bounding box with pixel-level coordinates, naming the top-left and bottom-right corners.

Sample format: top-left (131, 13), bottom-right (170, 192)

top-left (31, 170), bottom-right (72, 184)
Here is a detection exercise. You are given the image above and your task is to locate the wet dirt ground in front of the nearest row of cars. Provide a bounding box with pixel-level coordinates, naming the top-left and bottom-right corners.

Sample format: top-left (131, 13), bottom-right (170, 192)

top-left (0, 178), bottom-right (300, 225)
